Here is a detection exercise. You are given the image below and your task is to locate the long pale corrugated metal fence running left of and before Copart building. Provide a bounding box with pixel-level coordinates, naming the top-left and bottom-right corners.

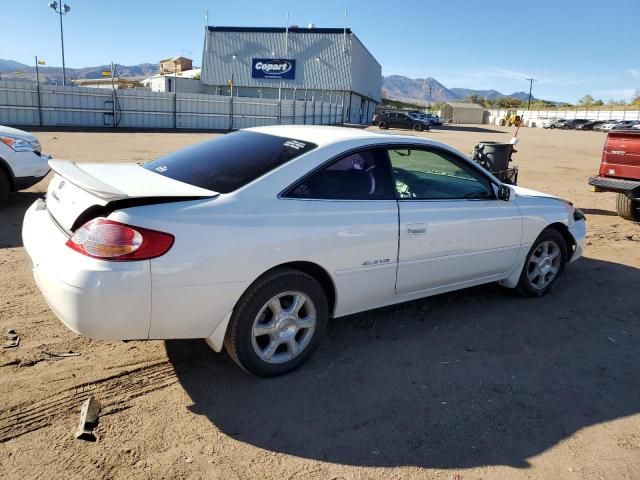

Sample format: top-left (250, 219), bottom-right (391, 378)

top-left (0, 80), bottom-right (344, 130)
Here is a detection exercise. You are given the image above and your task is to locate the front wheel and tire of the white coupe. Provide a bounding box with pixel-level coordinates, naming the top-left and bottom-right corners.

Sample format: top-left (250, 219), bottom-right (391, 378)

top-left (516, 228), bottom-right (567, 297)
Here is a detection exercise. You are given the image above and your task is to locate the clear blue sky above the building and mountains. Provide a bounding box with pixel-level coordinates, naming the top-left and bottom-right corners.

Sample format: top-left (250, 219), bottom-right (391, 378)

top-left (0, 0), bottom-right (640, 102)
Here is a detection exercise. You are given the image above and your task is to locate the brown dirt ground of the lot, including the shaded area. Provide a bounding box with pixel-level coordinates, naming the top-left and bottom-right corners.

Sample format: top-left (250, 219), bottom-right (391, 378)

top-left (0, 127), bottom-right (640, 480)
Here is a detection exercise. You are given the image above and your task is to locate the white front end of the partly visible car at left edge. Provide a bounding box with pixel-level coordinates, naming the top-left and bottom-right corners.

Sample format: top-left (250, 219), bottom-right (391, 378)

top-left (0, 125), bottom-right (51, 191)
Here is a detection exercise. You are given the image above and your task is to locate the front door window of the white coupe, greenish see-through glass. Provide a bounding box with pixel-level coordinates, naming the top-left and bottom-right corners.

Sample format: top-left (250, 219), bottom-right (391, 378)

top-left (388, 148), bottom-right (495, 200)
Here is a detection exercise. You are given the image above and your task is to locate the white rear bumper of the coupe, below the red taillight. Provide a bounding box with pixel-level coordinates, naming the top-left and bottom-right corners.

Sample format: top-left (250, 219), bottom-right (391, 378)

top-left (22, 199), bottom-right (151, 340)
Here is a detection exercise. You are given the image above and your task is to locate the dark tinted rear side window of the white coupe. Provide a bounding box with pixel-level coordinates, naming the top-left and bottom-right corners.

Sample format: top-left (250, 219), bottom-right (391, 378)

top-left (284, 148), bottom-right (395, 200)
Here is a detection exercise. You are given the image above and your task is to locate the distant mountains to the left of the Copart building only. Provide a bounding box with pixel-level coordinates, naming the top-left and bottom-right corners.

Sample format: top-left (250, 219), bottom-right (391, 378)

top-left (0, 59), bottom-right (159, 84)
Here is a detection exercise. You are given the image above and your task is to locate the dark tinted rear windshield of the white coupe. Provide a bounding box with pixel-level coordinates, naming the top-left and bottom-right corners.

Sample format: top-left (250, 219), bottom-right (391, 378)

top-left (144, 131), bottom-right (317, 193)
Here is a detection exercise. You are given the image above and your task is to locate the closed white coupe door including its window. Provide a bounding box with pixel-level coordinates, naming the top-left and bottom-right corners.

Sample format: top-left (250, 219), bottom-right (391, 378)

top-left (388, 146), bottom-right (522, 295)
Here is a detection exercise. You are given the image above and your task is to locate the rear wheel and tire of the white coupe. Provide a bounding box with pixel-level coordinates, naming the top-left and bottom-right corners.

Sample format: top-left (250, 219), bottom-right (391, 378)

top-left (224, 268), bottom-right (329, 378)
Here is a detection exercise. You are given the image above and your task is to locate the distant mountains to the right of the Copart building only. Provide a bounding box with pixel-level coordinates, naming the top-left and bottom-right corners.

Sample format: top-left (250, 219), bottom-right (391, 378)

top-left (382, 75), bottom-right (536, 102)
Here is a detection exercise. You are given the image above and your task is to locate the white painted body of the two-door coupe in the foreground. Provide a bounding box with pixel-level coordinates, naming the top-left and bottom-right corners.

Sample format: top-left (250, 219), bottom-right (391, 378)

top-left (23, 126), bottom-right (585, 351)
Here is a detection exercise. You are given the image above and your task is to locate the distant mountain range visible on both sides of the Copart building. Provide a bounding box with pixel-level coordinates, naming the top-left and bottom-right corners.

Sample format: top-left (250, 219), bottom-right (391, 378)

top-left (0, 59), bottom-right (535, 102)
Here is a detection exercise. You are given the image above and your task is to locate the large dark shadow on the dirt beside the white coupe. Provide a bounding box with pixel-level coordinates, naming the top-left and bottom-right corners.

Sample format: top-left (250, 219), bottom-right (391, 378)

top-left (165, 255), bottom-right (640, 468)
